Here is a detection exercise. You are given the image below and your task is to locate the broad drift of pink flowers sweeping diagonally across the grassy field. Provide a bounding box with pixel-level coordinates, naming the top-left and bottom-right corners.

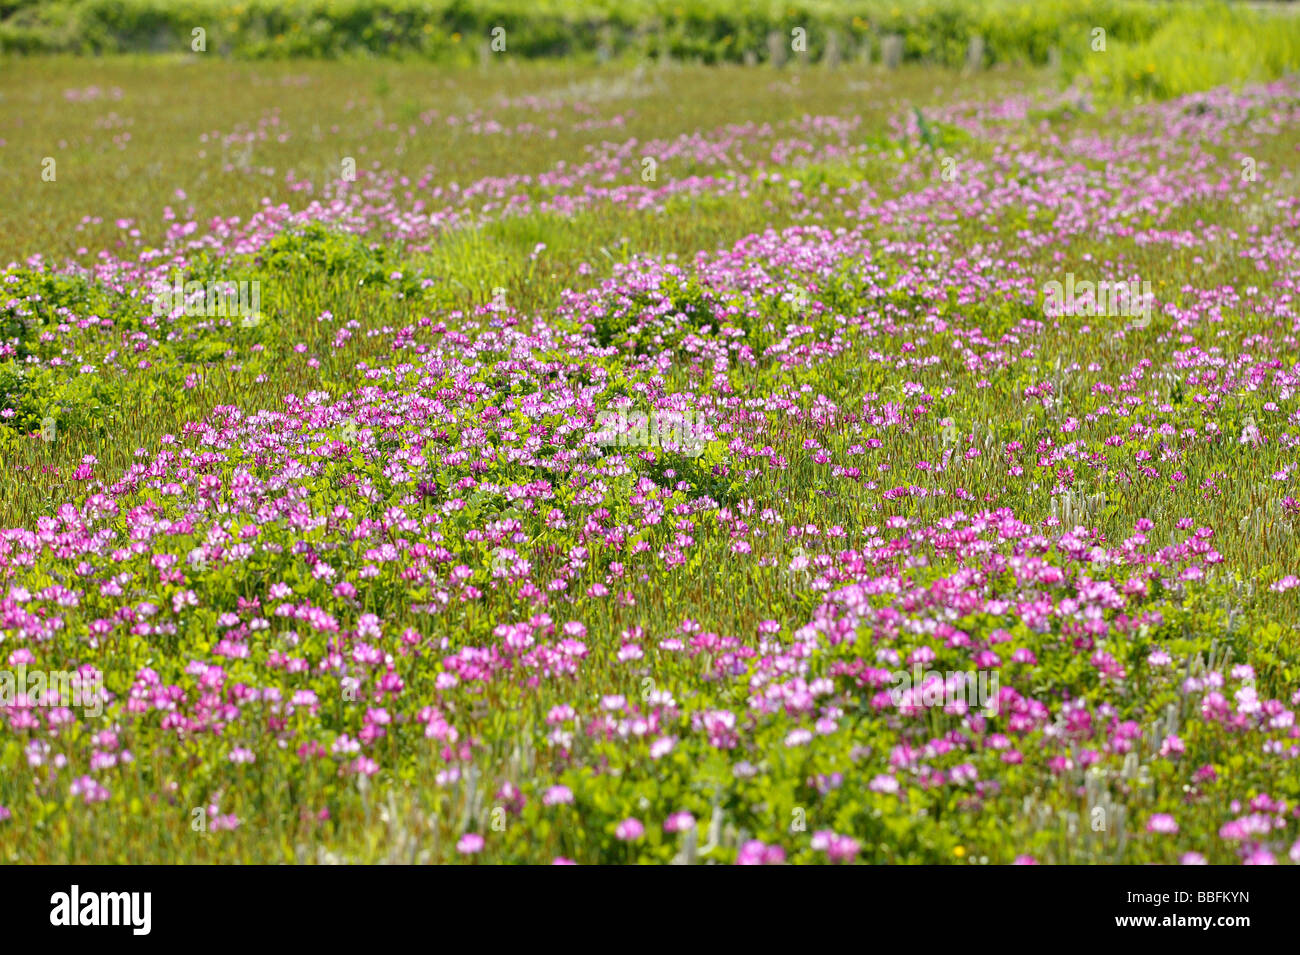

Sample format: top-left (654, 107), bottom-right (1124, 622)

top-left (0, 76), bottom-right (1300, 864)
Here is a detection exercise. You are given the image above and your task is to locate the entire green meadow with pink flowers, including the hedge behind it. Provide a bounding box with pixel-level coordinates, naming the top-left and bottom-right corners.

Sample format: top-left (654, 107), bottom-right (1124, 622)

top-left (0, 0), bottom-right (1300, 864)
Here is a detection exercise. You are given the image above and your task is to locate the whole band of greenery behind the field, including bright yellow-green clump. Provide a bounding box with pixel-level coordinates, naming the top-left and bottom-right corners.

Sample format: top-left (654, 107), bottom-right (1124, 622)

top-left (0, 0), bottom-right (1300, 96)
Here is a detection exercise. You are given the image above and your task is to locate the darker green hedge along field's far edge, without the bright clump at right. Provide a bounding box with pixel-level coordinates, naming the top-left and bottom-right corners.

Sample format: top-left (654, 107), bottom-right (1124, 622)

top-left (0, 0), bottom-right (1178, 66)
